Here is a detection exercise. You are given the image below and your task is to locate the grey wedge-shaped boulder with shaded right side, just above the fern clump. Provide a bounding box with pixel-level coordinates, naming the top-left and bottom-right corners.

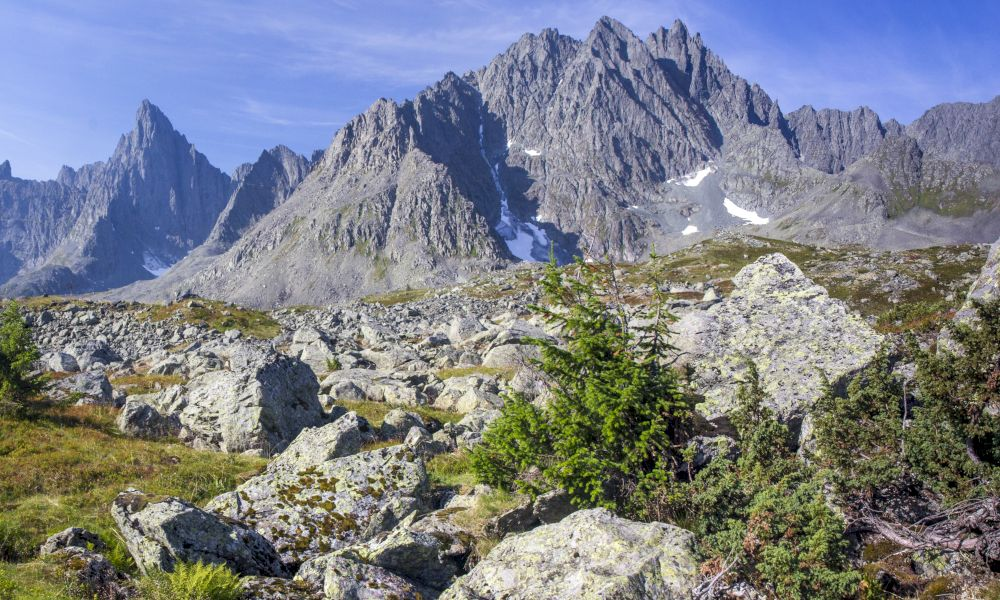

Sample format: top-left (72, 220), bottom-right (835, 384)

top-left (111, 490), bottom-right (287, 577)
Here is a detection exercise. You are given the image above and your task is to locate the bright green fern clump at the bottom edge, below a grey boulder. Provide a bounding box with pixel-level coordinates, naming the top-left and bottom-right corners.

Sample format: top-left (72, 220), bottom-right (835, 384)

top-left (138, 562), bottom-right (240, 600)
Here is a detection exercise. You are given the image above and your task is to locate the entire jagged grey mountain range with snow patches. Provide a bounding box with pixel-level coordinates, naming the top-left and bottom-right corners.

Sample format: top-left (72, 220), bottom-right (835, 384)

top-left (0, 17), bottom-right (1000, 306)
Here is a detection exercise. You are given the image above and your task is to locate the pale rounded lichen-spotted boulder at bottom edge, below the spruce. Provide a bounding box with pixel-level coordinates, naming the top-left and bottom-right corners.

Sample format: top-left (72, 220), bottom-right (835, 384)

top-left (441, 509), bottom-right (698, 600)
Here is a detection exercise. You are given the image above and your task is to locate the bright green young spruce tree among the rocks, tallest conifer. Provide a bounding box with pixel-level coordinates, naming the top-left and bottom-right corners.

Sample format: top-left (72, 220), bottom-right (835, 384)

top-left (472, 262), bottom-right (691, 510)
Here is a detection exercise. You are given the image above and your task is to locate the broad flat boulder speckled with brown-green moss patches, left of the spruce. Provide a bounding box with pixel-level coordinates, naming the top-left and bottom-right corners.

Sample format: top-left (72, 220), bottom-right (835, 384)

top-left (208, 445), bottom-right (427, 564)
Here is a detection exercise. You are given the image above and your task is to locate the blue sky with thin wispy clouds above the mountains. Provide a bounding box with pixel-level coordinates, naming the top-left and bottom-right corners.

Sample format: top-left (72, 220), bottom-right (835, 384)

top-left (0, 0), bottom-right (1000, 179)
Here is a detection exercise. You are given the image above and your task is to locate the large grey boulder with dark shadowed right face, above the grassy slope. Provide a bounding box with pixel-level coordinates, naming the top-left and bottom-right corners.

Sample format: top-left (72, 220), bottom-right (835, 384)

top-left (138, 342), bottom-right (326, 456)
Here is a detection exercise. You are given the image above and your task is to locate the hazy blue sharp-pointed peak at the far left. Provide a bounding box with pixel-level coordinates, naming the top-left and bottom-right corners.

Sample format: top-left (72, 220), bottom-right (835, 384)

top-left (4, 101), bottom-right (231, 295)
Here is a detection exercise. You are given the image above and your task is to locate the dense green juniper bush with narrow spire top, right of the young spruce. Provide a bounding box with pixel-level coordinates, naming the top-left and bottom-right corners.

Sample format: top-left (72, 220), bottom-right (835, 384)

top-left (647, 365), bottom-right (860, 600)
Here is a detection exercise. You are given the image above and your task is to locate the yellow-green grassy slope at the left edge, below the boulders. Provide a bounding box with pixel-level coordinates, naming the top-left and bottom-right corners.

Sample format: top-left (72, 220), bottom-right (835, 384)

top-left (0, 401), bottom-right (267, 598)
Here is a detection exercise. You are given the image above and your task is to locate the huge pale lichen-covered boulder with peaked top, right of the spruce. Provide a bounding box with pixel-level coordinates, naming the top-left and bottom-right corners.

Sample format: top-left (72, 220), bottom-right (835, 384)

top-left (674, 254), bottom-right (883, 426)
